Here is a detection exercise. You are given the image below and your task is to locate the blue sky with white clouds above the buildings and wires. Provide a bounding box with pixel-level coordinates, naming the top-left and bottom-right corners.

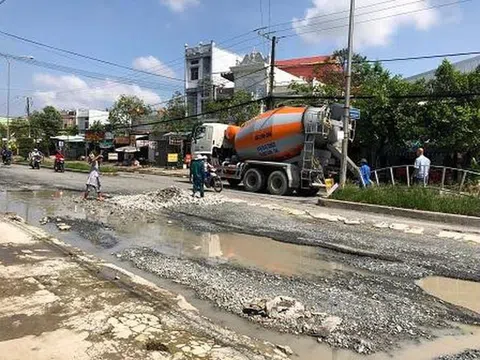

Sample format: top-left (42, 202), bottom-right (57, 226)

top-left (0, 0), bottom-right (480, 115)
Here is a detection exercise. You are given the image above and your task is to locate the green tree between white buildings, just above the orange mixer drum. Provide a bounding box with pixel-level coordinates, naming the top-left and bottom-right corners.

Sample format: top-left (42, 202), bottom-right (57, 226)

top-left (205, 90), bottom-right (260, 125)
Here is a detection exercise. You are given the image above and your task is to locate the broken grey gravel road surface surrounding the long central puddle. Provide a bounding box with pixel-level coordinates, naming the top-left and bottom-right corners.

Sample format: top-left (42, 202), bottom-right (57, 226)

top-left (2, 167), bottom-right (480, 359)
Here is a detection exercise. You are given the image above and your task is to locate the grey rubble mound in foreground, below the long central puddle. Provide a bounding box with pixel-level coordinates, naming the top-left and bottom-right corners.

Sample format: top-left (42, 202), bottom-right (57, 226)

top-left (120, 247), bottom-right (475, 354)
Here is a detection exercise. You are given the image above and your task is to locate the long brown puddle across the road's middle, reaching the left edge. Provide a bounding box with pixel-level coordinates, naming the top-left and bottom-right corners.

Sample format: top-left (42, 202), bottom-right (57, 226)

top-left (0, 191), bottom-right (358, 276)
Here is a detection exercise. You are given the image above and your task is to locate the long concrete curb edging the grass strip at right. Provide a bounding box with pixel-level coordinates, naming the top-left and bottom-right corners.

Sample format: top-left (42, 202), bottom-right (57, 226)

top-left (317, 199), bottom-right (480, 228)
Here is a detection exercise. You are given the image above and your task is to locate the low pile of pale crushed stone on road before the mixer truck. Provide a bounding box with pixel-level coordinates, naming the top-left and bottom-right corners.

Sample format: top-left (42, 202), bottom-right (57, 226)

top-left (108, 186), bottom-right (227, 211)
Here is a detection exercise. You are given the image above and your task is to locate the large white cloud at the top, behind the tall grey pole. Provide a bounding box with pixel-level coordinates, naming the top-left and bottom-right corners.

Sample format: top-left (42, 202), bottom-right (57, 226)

top-left (293, 0), bottom-right (440, 48)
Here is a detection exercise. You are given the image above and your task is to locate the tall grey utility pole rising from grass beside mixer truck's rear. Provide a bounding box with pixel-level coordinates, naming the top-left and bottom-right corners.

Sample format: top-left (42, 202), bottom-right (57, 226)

top-left (340, 0), bottom-right (355, 188)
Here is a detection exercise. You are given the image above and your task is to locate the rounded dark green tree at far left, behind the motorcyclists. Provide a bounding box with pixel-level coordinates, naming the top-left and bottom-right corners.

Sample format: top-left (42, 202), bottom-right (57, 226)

top-left (30, 106), bottom-right (63, 142)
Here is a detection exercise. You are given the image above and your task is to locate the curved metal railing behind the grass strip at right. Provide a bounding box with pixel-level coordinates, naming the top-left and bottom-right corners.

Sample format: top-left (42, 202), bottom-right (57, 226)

top-left (371, 165), bottom-right (480, 196)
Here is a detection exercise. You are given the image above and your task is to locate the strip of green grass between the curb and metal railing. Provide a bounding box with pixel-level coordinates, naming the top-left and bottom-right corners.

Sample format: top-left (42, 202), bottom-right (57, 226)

top-left (331, 186), bottom-right (480, 216)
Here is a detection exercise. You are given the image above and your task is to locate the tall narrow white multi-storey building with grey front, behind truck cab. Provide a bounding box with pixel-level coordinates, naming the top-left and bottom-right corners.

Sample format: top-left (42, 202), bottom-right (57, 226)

top-left (185, 41), bottom-right (241, 115)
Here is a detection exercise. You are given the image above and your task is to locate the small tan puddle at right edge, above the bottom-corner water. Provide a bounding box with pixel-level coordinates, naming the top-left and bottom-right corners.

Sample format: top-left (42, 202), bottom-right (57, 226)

top-left (417, 276), bottom-right (480, 314)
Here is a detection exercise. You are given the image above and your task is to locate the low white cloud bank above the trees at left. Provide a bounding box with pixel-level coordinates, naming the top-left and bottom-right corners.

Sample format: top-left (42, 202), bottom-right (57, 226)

top-left (33, 74), bottom-right (161, 109)
